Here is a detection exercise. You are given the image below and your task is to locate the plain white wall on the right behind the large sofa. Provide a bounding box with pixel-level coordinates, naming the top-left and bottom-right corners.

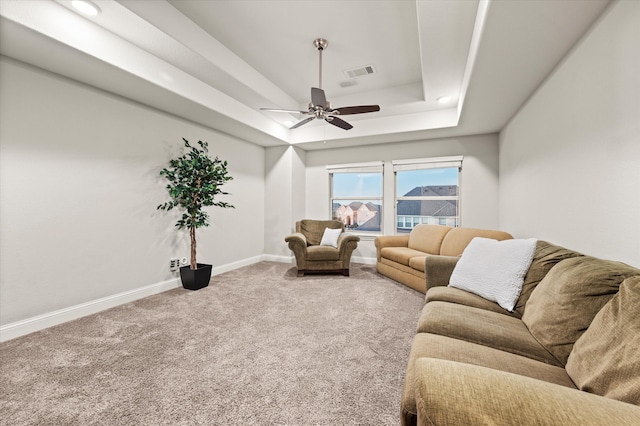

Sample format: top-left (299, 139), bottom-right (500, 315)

top-left (500, 0), bottom-right (640, 267)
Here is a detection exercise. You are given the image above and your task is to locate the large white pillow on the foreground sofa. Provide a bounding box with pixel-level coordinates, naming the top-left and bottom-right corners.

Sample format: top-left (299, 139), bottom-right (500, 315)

top-left (449, 237), bottom-right (537, 312)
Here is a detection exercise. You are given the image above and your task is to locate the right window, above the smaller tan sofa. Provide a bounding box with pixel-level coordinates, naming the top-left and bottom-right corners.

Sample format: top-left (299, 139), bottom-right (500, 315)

top-left (393, 157), bottom-right (462, 234)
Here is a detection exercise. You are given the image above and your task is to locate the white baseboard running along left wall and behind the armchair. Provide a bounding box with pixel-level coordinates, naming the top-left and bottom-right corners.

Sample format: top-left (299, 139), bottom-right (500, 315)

top-left (0, 254), bottom-right (376, 342)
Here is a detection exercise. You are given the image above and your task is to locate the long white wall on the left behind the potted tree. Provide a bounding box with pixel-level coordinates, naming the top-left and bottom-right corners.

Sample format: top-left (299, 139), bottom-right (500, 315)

top-left (0, 57), bottom-right (265, 325)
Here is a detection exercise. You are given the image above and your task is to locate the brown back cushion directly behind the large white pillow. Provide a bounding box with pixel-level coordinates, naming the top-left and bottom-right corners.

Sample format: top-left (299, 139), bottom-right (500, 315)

top-left (516, 240), bottom-right (582, 316)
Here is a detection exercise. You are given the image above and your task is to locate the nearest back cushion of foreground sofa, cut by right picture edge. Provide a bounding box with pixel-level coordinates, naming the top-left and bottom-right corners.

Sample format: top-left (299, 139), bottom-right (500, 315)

top-left (567, 277), bottom-right (640, 405)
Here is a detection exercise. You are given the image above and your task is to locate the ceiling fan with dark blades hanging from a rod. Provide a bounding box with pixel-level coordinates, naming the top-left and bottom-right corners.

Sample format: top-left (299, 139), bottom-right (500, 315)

top-left (260, 38), bottom-right (380, 130)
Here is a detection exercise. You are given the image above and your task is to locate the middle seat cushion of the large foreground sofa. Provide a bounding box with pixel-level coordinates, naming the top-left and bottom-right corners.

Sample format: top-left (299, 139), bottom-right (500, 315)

top-left (417, 302), bottom-right (560, 366)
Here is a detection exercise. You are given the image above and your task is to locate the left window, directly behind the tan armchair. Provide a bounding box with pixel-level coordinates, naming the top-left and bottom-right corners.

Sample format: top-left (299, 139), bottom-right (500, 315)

top-left (327, 162), bottom-right (383, 233)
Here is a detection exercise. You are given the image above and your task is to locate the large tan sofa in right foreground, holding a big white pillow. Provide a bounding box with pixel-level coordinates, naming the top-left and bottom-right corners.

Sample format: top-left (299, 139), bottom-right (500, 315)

top-left (401, 241), bottom-right (640, 426)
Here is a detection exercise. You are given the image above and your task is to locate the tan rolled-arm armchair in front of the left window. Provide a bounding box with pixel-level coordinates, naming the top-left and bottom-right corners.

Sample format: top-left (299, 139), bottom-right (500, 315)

top-left (284, 219), bottom-right (360, 277)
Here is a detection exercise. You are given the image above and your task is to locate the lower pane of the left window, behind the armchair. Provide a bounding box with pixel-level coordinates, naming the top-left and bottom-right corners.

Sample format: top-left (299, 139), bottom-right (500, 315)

top-left (332, 199), bottom-right (382, 232)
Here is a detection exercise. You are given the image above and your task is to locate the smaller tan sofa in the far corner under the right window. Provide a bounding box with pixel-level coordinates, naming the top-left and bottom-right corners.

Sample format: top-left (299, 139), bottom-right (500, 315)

top-left (375, 224), bottom-right (513, 293)
